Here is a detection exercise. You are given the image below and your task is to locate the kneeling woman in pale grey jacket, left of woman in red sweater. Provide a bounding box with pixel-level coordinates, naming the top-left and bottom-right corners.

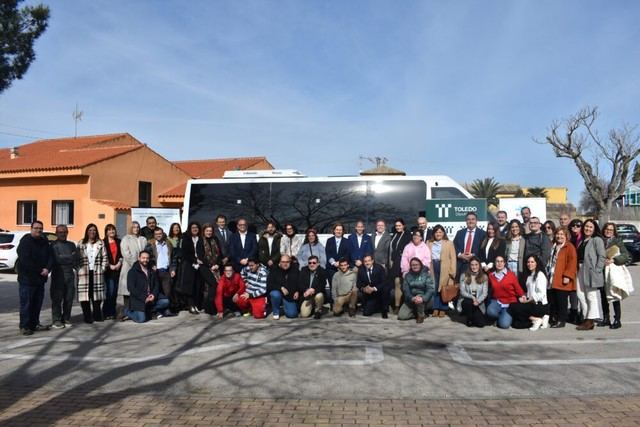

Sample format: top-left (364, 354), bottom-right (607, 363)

top-left (458, 256), bottom-right (489, 328)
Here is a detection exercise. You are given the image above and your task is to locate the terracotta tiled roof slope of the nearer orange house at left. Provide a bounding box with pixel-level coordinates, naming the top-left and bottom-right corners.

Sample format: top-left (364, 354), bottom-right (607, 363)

top-left (0, 133), bottom-right (144, 174)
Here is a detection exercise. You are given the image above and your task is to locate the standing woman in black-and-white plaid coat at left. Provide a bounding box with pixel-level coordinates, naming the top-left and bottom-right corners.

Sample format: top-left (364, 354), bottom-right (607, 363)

top-left (78, 224), bottom-right (108, 323)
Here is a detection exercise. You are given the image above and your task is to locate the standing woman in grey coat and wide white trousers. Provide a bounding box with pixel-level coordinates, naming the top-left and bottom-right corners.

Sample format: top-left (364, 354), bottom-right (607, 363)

top-left (576, 219), bottom-right (607, 331)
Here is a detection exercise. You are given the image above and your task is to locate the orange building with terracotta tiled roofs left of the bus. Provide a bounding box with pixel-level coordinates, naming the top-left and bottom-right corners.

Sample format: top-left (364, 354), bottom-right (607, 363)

top-left (0, 133), bottom-right (273, 240)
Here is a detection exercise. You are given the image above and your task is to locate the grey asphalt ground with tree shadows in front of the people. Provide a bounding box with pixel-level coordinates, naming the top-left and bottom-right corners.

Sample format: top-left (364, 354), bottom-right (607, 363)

top-left (0, 266), bottom-right (640, 399)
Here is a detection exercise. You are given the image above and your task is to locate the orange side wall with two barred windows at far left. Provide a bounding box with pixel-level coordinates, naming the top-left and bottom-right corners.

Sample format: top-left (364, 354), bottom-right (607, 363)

top-left (0, 176), bottom-right (90, 240)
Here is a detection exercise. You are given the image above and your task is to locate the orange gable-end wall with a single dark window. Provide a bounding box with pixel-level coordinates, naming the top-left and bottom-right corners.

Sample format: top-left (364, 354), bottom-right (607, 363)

top-left (83, 146), bottom-right (189, 207)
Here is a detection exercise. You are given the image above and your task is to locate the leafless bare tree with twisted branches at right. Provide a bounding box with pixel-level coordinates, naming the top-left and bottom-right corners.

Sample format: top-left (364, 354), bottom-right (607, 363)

top-left (535, 107), bottom-right (640, 222)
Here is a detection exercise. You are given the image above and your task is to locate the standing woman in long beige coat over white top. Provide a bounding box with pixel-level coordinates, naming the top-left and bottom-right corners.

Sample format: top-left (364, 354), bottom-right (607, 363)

top-left (428, 224), bottom-right (458, 317)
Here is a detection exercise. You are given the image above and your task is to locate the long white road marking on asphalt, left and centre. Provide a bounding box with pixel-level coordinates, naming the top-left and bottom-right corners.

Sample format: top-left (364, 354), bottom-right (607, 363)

top-left (0, 337), bottom-right (384, 366)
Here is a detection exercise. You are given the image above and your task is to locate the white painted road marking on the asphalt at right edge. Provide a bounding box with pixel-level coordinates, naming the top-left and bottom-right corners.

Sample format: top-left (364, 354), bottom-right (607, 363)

top-left (447, 338), bottom-right (640, 366)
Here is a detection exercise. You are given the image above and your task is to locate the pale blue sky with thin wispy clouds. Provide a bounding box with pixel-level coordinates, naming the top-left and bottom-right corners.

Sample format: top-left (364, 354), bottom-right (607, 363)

top-left (0, 0), bottom-right (640, 202)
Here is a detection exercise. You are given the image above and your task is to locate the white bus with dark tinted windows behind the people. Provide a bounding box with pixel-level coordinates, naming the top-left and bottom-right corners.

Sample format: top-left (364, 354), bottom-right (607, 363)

top-left (182, 170), bottom-right (473, 237)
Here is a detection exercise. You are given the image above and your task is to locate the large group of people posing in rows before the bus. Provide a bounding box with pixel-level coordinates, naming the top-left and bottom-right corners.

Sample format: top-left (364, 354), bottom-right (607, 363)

top-left (18, 208), bottom-right (631, 335)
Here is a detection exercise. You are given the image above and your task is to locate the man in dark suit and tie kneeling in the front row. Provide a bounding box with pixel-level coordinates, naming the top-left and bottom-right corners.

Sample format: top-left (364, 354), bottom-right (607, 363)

top-left (356, 254), bottom-right (389, 319)
